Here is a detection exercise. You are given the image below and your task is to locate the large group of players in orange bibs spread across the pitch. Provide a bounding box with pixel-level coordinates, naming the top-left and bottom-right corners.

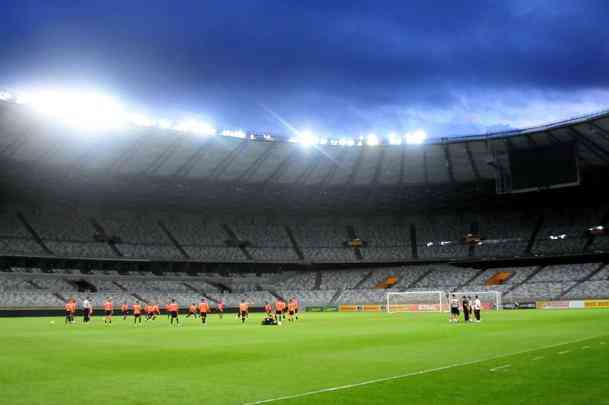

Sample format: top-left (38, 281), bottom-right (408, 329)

top-left (64, 297), bottom-right (299, 326)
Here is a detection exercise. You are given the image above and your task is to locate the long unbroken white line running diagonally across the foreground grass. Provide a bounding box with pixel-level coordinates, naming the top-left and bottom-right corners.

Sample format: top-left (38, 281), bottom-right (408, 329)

top-left (243, 334), bottom-right (606, 405)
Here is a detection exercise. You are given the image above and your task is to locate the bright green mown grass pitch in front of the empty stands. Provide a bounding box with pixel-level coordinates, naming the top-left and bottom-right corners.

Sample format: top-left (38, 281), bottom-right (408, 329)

top-left (0, 309), bottom-right (609, 405)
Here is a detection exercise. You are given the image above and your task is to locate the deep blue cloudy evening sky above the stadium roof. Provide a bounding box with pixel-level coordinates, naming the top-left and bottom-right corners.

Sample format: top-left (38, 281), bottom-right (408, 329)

top-left (0, 0), bottom-right (609, 136)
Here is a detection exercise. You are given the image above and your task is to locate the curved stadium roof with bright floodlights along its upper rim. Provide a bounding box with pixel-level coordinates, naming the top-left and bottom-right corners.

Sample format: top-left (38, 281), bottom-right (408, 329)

top-left (0, 102), bottom-right (609, 208)
